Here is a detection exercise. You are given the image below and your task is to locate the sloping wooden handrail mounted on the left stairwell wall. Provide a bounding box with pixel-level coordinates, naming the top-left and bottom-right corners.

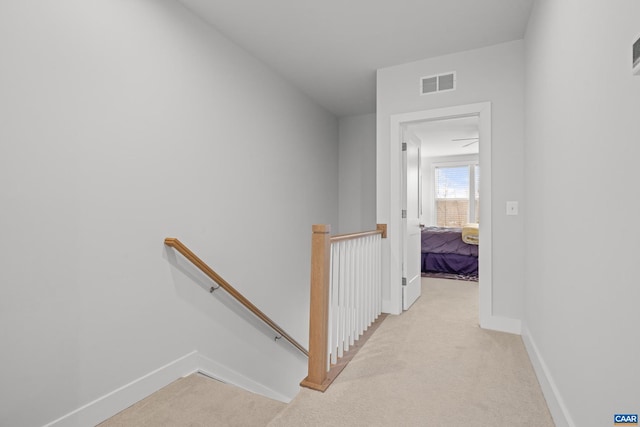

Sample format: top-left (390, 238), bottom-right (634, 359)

top-left (164, 237), bottom-right (309, 356)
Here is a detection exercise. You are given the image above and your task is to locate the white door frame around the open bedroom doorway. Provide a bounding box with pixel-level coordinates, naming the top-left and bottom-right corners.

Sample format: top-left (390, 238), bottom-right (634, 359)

top-left (383, 102), bottom-right (494, 329)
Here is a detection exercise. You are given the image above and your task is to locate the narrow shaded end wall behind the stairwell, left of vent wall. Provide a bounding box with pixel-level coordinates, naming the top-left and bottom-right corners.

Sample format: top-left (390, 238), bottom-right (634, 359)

top-left (333, 114), bottom-right (376, 234)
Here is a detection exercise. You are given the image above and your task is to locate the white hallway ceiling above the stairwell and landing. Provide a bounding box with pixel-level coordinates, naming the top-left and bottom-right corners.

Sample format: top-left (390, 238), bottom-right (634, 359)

top-left (180, 0), bottom-right (533, 116)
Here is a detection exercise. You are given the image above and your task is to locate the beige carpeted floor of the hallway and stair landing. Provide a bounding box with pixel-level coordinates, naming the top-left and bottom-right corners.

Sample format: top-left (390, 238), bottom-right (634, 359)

top-left (101, 278), bottom-right (554, 427)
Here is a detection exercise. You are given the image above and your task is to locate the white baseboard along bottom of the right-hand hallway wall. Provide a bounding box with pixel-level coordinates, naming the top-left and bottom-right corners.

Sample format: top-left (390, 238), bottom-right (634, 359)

top-left (522, 326), bottom-right (575, 427)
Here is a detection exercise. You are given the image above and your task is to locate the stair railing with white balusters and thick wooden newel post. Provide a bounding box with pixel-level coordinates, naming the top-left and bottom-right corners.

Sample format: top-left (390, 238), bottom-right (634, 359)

top-left (301, 224), bottom-right (386, 391)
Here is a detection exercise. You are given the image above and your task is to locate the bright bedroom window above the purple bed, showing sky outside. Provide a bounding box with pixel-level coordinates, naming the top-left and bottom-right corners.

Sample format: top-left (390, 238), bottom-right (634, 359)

top-left (434, 163), bottom-right (480, 227)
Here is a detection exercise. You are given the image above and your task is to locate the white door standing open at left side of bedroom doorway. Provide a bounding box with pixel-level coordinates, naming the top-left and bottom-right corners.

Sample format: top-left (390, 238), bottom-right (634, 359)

top-left (401, 129), bottom-right (422, 310)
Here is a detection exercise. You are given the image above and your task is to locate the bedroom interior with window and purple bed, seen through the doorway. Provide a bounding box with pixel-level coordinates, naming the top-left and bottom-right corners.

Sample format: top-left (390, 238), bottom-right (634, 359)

top-left (406, 116), bottom-right (480, 282)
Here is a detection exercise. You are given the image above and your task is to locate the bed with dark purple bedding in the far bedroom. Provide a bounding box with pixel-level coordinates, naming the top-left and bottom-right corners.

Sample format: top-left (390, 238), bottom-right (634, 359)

top-left (421, 226), bottom-right (478, 277)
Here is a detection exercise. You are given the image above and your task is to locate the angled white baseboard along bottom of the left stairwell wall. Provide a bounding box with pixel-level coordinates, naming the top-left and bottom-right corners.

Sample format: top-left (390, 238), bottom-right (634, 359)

top-left (44, 351), bottom-right (294, 427)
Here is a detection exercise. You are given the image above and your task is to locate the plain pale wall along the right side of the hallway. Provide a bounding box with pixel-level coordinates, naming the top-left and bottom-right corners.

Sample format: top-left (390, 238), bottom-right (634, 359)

top-left (525, 0), bottom-right (640, 427)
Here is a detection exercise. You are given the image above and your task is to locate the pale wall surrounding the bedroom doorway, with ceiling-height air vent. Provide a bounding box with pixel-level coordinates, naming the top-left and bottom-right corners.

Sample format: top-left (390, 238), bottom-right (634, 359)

top-left (376, 41), bottom-right (524, 319)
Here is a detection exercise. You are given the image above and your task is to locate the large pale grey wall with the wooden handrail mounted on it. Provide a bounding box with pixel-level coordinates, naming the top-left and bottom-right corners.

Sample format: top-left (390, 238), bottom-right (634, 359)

top-left (0, 0), bottom-right (338, 426)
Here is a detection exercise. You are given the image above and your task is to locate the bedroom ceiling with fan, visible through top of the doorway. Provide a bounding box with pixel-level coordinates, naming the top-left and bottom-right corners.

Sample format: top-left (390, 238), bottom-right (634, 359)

top-left (406, 116), bottom-right (479, 157)
